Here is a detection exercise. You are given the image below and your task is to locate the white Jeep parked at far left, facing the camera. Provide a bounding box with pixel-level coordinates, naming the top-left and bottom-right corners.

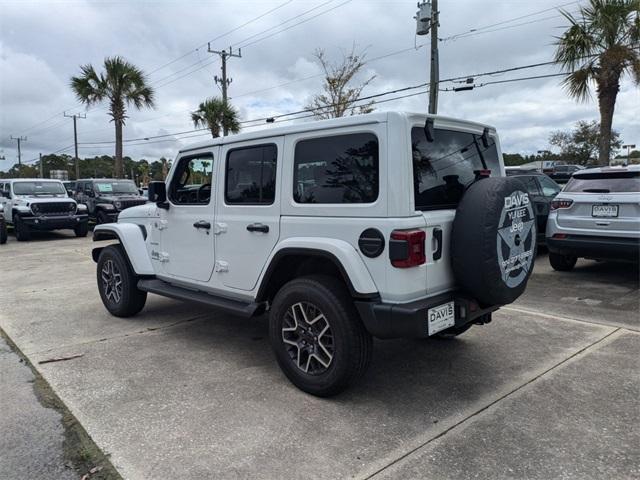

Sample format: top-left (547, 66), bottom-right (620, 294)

top-left (0, 178), bottom-right (89, 241)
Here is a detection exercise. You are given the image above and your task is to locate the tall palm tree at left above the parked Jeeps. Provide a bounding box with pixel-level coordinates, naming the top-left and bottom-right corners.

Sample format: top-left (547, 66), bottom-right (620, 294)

top-left (71, 56), bottom-right (155, 178)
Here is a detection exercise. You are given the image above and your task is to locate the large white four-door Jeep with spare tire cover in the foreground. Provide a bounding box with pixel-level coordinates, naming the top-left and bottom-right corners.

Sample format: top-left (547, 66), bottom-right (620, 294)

top-left (93, 113), bottom-right (536, 396)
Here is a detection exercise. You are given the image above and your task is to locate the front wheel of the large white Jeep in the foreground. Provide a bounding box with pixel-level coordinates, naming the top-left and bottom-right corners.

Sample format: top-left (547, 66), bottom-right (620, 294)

top-left (97, 245), bottom-right (147, 317)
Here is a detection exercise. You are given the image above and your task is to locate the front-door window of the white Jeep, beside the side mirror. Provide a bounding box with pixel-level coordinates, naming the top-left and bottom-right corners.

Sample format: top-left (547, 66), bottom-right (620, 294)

top-left (169, 153), bottom-right (213, 205)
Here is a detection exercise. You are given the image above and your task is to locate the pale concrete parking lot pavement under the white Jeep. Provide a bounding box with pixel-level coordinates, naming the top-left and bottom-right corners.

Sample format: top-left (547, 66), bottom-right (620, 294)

top-left (0, 233), bottom-right (640, 479)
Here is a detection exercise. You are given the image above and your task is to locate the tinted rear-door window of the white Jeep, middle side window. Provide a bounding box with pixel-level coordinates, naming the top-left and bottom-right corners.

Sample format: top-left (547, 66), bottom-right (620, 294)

top-left (224, 144), bottom-right (278, 205)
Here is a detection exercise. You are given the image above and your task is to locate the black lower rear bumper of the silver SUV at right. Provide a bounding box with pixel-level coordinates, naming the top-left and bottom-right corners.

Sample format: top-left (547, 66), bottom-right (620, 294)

top-left (547, 235), bottom-right (640, 261)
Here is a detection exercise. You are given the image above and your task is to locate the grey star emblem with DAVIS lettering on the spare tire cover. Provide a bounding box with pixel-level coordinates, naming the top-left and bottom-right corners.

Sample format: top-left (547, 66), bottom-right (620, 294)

top-left (496, 190), bottom-right (536, 288)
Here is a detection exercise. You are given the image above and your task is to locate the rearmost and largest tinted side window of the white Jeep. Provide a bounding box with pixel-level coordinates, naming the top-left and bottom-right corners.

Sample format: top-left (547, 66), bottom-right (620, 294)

top-left (293, 133), bottom-right (379, 203)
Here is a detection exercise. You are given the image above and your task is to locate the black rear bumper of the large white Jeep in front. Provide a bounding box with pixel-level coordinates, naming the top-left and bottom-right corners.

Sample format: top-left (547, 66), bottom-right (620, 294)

top-left (355, 292), bottom-right (499, 338)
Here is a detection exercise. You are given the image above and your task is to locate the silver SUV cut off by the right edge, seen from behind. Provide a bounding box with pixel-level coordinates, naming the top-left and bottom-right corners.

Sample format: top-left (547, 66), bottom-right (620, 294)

top-left (546, 165), bottom-right (640, 271)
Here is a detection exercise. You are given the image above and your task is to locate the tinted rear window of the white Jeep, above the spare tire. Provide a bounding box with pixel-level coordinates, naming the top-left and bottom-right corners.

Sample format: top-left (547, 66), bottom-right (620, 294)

top-left (411, 127), bottom-right (500, 210)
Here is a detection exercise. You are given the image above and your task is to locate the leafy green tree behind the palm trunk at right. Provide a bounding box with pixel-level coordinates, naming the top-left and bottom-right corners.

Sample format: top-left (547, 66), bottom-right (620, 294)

top-left (549, 120), bottom-right (622, 165)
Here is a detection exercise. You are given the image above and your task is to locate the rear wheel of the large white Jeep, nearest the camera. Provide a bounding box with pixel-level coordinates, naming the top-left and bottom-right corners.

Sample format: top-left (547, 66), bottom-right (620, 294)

top-left (269, 275), bottom-right (372, 397)
